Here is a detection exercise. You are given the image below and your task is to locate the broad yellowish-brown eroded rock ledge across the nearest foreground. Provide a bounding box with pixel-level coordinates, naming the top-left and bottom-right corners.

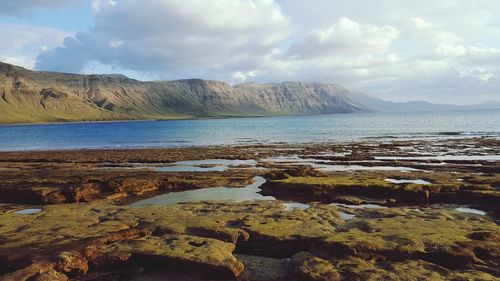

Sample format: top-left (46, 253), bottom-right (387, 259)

top-left (0, 201), bottom-right (500, 280)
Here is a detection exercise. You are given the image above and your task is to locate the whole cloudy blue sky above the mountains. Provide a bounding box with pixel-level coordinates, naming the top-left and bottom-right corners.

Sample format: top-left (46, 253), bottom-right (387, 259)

top-left (0, 0), bottom-right (500, 104)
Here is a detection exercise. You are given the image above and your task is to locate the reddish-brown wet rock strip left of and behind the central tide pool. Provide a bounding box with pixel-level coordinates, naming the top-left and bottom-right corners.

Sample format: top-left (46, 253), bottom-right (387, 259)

top-left (0, 167), bottom-right (255, 204)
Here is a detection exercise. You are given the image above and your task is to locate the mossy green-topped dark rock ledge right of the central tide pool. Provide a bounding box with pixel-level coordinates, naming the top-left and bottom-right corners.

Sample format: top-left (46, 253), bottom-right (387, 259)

top-left (261, 168), bottom-right (500, 210)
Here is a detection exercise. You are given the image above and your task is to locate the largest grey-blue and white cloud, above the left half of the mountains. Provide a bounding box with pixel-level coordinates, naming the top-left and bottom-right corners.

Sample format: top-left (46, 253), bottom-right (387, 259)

top-left (37, 0), bottom-right (291, 78)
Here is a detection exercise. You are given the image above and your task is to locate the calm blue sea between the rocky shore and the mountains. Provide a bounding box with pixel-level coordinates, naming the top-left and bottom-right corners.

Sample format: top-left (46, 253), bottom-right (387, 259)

top-left (0, 110), bottom-right (500, 151)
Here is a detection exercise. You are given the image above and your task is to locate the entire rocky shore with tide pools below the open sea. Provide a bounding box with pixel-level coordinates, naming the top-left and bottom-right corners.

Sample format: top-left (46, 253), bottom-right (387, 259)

top-left (0, 138), bottom-right (500, 280)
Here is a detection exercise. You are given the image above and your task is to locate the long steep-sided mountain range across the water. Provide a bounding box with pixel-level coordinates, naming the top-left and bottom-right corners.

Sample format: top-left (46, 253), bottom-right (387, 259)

top-left (0, 62), bottom-right (500, 123)
